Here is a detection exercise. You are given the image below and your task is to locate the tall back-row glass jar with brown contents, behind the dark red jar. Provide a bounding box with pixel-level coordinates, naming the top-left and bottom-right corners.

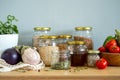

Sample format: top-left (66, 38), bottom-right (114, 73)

top-left (74, 26), bottom-right (93, 50)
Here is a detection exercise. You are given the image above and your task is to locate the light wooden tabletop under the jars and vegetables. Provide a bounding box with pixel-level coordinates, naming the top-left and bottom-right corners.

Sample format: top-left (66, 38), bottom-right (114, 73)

top-left (0, 67), bottom-right (120, 80)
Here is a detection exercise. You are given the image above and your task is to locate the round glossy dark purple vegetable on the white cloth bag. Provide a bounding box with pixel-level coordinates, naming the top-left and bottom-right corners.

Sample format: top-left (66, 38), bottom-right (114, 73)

top-left (1, 48), bottom-right (22, 65)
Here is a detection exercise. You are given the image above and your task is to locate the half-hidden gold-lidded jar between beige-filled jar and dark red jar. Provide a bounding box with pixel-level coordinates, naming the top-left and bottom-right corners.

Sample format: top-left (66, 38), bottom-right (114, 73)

top-left (58, 35), bottom-right (72, 51)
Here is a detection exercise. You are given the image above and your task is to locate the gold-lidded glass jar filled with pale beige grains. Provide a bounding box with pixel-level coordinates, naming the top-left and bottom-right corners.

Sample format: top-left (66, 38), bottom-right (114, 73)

top-left (38, 35), bottom-right (59, 66)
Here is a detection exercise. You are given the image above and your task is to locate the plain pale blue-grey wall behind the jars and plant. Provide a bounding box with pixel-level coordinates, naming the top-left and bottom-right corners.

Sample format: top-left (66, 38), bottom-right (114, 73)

top-left (0, 0), bottom-right (120, 49)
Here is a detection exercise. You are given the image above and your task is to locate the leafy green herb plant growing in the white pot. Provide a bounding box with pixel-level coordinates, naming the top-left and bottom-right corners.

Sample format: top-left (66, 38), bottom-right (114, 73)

top-left (0, 15), bottom-right (19, 35)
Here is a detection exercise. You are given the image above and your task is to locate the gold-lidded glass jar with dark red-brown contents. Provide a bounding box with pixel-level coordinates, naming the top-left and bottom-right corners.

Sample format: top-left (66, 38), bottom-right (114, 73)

top-left (71, 41), bottom-right (87, 66)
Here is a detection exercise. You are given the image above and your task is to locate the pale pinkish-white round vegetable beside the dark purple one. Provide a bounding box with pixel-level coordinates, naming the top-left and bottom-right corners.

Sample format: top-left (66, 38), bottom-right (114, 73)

top-left (22, 48), bottom-right (41, 65)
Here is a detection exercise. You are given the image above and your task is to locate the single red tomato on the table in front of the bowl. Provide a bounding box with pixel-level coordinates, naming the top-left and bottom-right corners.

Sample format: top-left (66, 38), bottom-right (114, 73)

top-left (96, 58), bottom-right (108, 69)
